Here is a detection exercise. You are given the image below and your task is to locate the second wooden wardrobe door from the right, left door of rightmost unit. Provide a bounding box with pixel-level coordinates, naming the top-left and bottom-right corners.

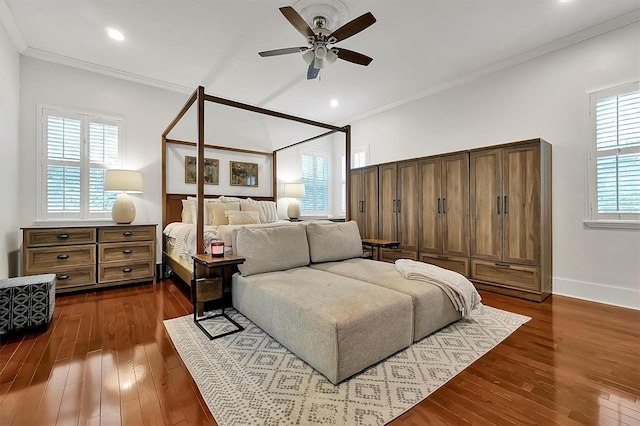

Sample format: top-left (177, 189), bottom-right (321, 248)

top-left (469, 148), bottom-right (503, 261)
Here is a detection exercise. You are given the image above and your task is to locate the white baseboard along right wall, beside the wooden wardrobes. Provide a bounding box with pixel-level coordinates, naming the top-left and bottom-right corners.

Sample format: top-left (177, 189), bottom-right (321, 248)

top-left (553, 277), bottom-right (640, 310)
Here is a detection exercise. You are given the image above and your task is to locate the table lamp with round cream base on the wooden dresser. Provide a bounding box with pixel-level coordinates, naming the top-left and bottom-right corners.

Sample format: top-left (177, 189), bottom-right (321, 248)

top-left (104, 169), bottom-right (142, 223)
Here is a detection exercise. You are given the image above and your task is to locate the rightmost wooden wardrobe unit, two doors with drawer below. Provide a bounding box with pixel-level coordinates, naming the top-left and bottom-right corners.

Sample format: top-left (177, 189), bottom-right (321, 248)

top-left (470, 140), bottom-right (552, 300)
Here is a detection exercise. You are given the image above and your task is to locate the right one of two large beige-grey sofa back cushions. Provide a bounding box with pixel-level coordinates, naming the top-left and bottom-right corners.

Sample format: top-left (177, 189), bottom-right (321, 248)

top-left (306, 220), bottom-right (362, 263)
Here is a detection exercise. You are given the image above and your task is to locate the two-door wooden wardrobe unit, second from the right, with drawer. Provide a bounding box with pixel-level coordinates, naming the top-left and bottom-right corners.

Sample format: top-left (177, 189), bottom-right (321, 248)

top-left (419, 153), bottom-right (469, 277)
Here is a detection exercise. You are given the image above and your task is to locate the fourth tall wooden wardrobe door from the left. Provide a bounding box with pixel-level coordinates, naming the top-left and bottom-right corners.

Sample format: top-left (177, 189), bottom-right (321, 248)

top-left (396, 161), bottom-right (419, 253)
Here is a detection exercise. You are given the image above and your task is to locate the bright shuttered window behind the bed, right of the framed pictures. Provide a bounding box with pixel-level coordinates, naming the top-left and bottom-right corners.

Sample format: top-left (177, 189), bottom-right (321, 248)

top-left (301, 152), bottom-right (329, 216)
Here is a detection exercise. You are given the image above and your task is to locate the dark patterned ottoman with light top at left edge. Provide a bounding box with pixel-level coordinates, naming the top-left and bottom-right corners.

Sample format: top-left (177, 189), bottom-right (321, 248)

top-left (0, 274), bottom-right (56, 333)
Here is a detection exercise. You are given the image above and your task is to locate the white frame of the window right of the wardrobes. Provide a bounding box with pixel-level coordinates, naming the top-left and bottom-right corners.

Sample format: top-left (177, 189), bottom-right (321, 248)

top-left (583, 82), bottom-right (640, 230)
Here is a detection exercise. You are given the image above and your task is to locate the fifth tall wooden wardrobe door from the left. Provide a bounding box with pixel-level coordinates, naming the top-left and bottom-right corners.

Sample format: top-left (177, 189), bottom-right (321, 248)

top-left (419, 158), bottom-right (442, 253)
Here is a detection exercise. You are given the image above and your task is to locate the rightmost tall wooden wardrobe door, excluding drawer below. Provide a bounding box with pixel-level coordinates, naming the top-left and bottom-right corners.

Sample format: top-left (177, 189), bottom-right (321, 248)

top-left (502, 144), bottom-right (540, 265)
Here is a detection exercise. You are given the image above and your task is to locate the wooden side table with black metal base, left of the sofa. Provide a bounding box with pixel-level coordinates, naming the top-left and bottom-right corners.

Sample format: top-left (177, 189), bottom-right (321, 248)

top-left (191, 254), bottom-right (245, 340)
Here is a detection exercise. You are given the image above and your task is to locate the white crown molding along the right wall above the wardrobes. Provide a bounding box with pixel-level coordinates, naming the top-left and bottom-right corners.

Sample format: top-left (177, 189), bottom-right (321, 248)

top-left (340, 10), bottom-right (640, 125)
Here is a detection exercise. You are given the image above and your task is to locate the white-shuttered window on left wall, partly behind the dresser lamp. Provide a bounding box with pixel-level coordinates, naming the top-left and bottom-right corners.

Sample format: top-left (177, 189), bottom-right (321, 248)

top-left (39, 108), bottom-right (124, 219)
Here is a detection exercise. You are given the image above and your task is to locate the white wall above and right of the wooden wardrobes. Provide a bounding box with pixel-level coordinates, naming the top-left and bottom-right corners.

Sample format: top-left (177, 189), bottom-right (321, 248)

top-left (351, 22), bottom-right (640, 309)
